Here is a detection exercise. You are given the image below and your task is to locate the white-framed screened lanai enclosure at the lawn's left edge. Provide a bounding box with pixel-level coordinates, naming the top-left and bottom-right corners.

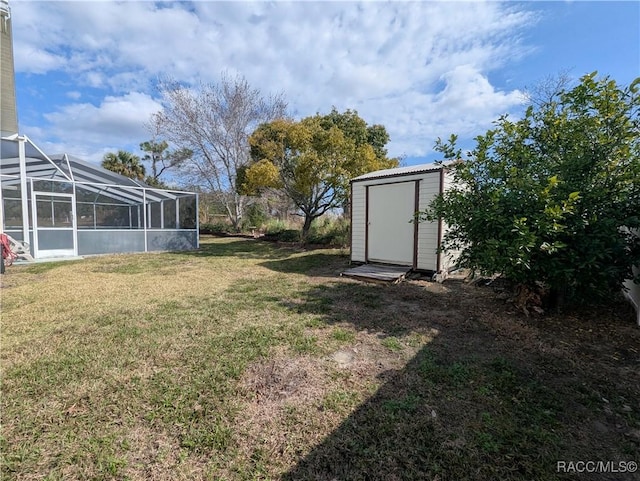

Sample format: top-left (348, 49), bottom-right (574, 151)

top-left (0, 134), bottom-right (198, 259)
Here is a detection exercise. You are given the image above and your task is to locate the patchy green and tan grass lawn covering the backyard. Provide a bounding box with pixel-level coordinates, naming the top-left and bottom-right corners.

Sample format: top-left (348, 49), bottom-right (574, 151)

top-left (0, 238), bottom-right (640, 481)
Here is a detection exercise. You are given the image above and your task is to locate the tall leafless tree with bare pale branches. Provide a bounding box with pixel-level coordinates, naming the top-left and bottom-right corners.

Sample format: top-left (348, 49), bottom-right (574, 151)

top-left (151, 74), bottom-right (286, 229)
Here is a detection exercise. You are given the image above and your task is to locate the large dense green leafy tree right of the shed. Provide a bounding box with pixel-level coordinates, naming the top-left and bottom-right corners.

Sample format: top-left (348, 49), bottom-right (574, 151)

top-left (420, 72), bottom-right (640, 307)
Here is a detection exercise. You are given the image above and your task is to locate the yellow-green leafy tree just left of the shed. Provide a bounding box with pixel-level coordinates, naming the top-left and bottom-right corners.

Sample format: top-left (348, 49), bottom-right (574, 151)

top-left (248, 109), bottom-right (397, 239)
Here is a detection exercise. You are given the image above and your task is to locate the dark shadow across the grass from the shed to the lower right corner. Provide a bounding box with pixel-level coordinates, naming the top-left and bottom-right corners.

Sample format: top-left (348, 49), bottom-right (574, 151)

top-left (276, 282), bottom-right (638, 481)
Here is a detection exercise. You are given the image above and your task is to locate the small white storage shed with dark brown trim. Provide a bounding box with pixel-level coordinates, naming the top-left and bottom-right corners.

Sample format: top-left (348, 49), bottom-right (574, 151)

top-left (351, 163), bottom-right (454, 273)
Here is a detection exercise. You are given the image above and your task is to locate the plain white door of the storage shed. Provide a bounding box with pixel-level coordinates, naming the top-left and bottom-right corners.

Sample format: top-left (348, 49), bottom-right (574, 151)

top-left (367, 182), bottom-right (416, 266)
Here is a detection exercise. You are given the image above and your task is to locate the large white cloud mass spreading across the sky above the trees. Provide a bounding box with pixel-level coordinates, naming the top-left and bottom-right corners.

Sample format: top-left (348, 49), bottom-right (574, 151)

top-left (11, 1), bottom-right (536, 163)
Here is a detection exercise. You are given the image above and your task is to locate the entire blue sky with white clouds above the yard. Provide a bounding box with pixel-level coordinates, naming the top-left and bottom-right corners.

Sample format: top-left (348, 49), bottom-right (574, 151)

top-left (10, 0), bottom-right (640, 169)
